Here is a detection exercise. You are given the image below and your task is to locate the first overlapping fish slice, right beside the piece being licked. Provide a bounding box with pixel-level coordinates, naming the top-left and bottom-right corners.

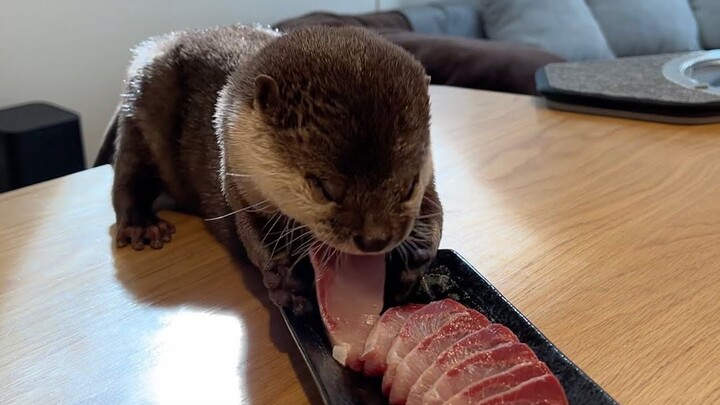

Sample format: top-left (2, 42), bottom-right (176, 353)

top-left (360, 304), bottom-right (424, 377)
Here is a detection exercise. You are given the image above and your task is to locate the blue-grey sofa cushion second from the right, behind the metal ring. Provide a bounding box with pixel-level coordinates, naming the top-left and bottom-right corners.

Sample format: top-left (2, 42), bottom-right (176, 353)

top-left (587, 0), bottom-right (700, 56)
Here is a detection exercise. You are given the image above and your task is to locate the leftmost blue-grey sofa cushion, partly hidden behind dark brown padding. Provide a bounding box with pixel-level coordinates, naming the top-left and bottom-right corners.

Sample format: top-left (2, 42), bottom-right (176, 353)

top-left (399, 2), bottom-right (482, 38)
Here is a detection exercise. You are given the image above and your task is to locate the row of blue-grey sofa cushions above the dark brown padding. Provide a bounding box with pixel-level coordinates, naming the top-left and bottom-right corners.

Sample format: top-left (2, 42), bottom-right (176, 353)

top-left (399, 0), bottom-right (720, 61)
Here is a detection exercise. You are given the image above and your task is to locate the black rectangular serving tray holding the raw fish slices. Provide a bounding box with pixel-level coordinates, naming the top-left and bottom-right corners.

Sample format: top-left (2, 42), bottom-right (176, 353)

top-left (282, 249), bottom-right (617, 405)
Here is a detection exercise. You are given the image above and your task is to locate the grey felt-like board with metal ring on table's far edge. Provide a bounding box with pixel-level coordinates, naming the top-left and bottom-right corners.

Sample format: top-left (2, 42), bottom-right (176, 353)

top-left (535, 50), bottom-right (720, 124)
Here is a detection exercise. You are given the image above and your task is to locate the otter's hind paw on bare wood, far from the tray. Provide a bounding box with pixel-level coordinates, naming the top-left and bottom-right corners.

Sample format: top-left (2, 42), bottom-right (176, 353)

top-left (115, 215), bottom-right (175, 250)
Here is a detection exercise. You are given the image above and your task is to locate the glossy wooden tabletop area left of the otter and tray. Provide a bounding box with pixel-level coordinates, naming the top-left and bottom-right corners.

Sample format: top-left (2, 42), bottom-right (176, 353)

top-left (0, 166), bottom-right (319, 405)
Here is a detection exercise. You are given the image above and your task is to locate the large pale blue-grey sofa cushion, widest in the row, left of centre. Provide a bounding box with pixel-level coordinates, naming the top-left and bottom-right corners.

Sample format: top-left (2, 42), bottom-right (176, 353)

top-left (481, 0), bottom-right (614, 61)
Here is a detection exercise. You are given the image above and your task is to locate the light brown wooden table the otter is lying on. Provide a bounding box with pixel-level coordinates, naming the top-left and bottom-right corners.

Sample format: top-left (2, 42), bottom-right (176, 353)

top-left (0, 87), bottom-right (720, 405)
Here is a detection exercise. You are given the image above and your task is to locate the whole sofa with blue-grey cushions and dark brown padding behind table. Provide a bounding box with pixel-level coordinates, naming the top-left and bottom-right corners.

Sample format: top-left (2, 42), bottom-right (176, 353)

top-left (276, 0), bottom-right (720, 94)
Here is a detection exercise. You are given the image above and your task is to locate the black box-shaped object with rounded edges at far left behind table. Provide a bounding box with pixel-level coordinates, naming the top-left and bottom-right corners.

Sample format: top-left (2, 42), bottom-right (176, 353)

top-left (0, 103), bottom-right (85, 192)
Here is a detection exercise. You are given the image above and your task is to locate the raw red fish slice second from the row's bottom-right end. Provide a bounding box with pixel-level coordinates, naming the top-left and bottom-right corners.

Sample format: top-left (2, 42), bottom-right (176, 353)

top-left (446, 362), bottom-right (552, 405)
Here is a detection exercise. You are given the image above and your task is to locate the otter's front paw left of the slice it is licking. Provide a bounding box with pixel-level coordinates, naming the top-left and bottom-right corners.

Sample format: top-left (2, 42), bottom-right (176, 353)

top-left (262, 257), bottom-right (312, 315)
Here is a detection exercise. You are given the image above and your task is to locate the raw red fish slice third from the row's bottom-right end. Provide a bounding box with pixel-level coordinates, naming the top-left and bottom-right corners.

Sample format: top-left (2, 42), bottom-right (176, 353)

top-left (423, 343), bottom-right (540, 405)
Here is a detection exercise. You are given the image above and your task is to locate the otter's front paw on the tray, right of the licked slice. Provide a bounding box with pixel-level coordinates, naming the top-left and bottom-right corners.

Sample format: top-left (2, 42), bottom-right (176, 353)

top-left (385, 249), bottom-right (436, 306)
